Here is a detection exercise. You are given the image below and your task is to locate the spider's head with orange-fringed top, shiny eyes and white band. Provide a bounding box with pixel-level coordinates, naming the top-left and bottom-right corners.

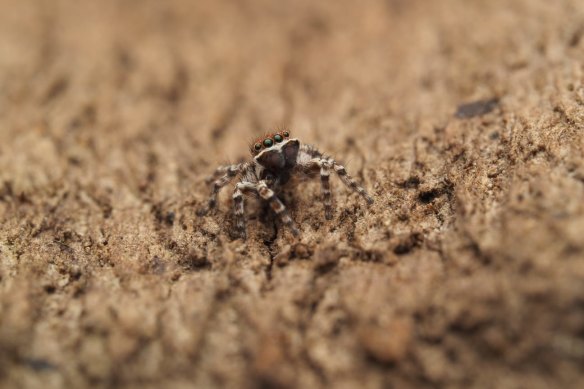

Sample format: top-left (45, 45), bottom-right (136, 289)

top-left (251, 130), bottom-right (300, 171)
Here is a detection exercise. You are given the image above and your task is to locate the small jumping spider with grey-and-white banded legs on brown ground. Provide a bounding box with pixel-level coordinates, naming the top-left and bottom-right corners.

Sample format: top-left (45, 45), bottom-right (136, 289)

top-left (200, 131), bottom-right (373, 239)
